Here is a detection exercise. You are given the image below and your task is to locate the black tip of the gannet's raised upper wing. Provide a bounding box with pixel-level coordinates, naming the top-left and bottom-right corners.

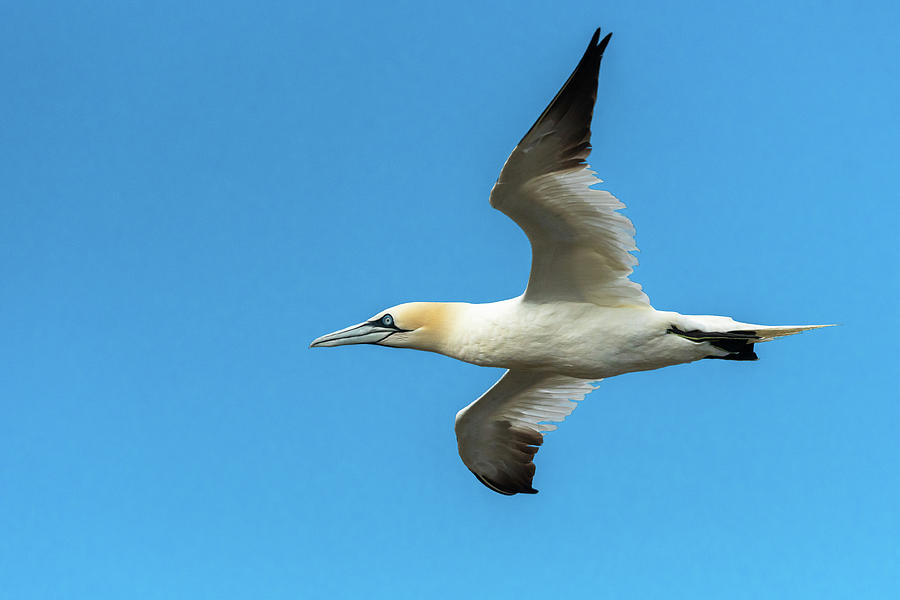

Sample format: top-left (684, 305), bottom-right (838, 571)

top-left (519, 27), bottom-right (612, 175)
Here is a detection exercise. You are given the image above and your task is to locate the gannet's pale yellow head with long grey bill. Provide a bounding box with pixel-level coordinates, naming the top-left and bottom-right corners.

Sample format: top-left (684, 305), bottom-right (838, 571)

top-left (309, 302), bottom-right (459, 352)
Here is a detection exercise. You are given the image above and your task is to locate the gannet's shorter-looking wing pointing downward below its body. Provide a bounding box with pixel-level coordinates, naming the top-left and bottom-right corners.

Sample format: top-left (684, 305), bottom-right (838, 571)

top-left (456, 371), bottom-right (594, 495)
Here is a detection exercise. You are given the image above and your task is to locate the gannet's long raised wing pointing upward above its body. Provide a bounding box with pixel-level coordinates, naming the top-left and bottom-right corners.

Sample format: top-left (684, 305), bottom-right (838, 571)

top-left (491, 29), bottom-right (650, 306)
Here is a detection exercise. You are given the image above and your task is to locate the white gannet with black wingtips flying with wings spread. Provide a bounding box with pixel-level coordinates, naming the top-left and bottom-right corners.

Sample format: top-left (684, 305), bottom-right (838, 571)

top-left (310, 29), bottom-right (827, 495)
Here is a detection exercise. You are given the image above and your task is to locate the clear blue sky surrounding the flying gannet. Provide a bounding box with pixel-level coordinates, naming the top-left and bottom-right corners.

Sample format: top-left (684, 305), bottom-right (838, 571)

top-left (0, 1), bottom-right (900, 600)
